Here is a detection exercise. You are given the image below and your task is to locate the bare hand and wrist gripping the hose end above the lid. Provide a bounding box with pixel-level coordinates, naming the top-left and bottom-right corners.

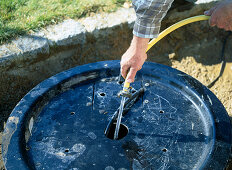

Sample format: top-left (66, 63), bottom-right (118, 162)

top-left (120, 36), bottom-right (149, 83)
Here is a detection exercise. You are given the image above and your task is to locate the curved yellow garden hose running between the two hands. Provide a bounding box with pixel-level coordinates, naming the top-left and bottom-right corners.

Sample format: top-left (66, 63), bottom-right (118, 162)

top-left (123, 15), bottom-right (210, 90)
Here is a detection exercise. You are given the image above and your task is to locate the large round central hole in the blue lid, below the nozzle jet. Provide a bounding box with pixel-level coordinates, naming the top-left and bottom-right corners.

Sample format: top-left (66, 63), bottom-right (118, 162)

top-left (106, 123), bottom-right (129, 140)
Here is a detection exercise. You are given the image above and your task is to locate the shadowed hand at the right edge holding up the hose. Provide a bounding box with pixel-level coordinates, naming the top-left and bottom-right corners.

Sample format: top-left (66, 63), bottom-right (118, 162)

top-left (204, 0), bottom-right (232, 31)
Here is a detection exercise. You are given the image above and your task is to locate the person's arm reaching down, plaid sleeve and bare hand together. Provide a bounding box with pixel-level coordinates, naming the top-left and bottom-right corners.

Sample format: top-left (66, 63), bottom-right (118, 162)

top-left (121, 0), bottom-right (173, 83)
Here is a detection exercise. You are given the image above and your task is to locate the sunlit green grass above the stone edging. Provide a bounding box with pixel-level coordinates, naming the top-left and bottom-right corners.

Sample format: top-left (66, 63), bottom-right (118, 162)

top-left (0, 0), bottom-right (128, 44)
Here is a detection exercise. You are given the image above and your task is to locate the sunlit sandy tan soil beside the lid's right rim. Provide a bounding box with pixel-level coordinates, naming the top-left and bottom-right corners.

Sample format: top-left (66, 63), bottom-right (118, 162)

top-left (172, 57), bottom-right (232, 117)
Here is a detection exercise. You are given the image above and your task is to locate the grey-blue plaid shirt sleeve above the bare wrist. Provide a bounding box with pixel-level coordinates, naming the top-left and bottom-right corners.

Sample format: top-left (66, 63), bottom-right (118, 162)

top-left (132, 0), bottom-right (174, 38)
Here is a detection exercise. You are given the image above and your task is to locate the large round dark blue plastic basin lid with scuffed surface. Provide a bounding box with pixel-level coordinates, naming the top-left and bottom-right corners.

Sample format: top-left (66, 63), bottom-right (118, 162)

top-left (2, 61), bottom-right (231, 170)
